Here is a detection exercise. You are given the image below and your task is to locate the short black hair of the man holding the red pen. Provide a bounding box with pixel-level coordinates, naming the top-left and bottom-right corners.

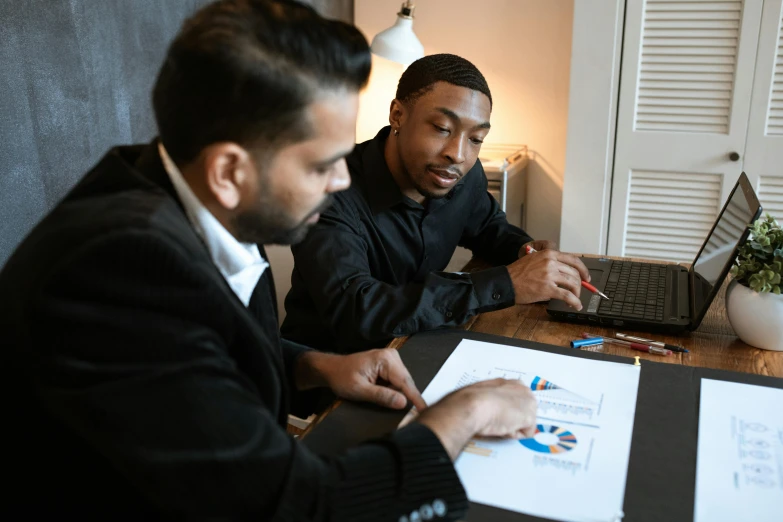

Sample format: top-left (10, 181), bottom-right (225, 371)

top-left (396, 54), bottom-right (492, 108)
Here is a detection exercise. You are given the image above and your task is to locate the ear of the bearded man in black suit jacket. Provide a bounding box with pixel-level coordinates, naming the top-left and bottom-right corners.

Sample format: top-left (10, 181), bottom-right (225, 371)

top-left (201, 142), bottom-right (255, 210)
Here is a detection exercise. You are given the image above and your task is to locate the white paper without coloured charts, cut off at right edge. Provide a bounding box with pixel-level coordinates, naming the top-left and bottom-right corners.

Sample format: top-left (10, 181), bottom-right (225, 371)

top-left (693, 379), bottom-right (783, 522)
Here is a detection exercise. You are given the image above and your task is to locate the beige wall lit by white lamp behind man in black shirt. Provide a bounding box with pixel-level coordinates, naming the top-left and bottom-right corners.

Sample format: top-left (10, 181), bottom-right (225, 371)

top-left (354, 0), bottom-right (574, 240)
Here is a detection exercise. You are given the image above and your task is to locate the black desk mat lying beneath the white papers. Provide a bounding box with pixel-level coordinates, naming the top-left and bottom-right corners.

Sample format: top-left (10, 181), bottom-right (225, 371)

top-left (303, 330), bottom-right (783, 522)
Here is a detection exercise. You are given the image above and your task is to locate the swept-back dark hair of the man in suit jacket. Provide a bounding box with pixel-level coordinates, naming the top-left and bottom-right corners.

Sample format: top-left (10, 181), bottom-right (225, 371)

top-left (152, 0), bottom-right (371, 163)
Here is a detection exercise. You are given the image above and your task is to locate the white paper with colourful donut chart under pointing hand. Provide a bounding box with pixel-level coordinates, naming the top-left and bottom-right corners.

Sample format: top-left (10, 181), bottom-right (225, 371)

top-left (423, 340), bottom-right (640, 522)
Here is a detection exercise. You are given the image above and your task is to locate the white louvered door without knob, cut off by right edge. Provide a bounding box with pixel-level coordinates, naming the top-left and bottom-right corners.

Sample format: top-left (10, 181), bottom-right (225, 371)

top-left (744, 0), bottom-right (783, 223)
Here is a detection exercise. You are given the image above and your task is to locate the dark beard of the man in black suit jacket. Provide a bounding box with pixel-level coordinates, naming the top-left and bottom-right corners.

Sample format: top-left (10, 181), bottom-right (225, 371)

top-left (232, 194), bottom-right (334, 245)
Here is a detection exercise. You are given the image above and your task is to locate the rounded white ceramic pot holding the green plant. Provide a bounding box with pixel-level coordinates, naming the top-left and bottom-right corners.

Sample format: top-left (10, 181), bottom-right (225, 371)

top-left (726, 281), bottom-right (783, 351)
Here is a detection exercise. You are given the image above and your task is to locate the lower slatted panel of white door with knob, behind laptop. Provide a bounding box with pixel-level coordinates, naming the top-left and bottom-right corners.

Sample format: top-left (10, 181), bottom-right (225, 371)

top-left (625, 170), bottom-right (721, 262)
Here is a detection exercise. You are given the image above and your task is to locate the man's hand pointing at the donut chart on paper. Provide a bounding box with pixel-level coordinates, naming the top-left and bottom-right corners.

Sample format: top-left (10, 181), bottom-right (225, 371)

top-left (417, 379), bottom-right (538, 460)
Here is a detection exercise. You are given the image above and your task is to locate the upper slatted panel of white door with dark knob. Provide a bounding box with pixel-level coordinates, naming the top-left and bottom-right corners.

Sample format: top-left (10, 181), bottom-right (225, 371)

top-left (635, 0), bottom-right (742, 134)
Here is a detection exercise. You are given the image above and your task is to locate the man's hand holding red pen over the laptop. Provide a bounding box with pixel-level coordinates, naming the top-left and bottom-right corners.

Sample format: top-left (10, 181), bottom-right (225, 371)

top-left (508, 250), bottom-right (590, 310)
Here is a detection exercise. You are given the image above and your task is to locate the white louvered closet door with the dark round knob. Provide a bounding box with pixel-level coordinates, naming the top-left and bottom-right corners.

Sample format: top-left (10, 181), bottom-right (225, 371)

top-left (608, 0), bottom-right (762, 261)
